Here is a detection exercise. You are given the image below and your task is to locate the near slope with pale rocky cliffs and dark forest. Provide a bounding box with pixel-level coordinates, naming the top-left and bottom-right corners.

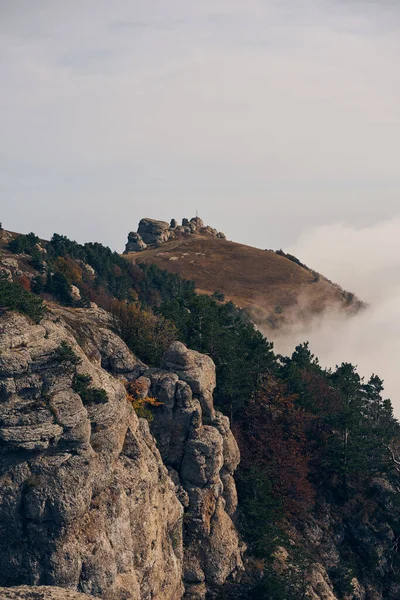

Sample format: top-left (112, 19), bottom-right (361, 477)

top-left (0, 221), bottom-right (400, 600)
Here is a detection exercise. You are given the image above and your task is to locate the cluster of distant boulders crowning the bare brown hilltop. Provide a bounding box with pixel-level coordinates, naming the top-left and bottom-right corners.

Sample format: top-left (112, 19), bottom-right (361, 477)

top-left (124, 217), bottom-right (226, 254)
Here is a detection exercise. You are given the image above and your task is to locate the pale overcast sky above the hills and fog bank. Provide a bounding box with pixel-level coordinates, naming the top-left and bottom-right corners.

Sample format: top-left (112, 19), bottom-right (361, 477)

top-left (0, 0), bottom-right (400, 250)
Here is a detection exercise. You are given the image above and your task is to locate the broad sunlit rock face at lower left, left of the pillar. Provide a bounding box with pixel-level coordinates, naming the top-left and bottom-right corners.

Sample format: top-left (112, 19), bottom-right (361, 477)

top-left (0, 309), bottom-right (183, 600)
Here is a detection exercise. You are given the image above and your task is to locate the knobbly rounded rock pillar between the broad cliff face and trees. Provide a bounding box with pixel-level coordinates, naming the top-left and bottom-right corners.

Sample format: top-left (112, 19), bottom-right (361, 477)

top-left (145, 342), bottom-right (242, 600)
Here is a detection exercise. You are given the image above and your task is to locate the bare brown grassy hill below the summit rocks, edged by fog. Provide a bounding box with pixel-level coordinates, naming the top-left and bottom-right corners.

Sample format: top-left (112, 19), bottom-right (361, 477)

top-left (124, 219), bottom-right (362, 328)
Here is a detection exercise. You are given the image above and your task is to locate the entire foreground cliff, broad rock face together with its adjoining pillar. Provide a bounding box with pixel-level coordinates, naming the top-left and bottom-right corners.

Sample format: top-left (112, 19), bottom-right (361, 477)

top-left (0, 306), bottom-right (242, 600)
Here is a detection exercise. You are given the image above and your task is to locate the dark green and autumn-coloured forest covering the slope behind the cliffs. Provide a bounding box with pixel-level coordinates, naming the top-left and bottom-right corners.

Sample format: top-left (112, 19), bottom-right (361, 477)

top-left (0, 229), bottom-right (400, 600)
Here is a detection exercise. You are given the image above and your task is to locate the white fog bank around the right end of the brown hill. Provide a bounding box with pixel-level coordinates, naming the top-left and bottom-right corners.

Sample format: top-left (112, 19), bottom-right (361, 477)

top-left (274, 217), bottom-right (400, 416)
